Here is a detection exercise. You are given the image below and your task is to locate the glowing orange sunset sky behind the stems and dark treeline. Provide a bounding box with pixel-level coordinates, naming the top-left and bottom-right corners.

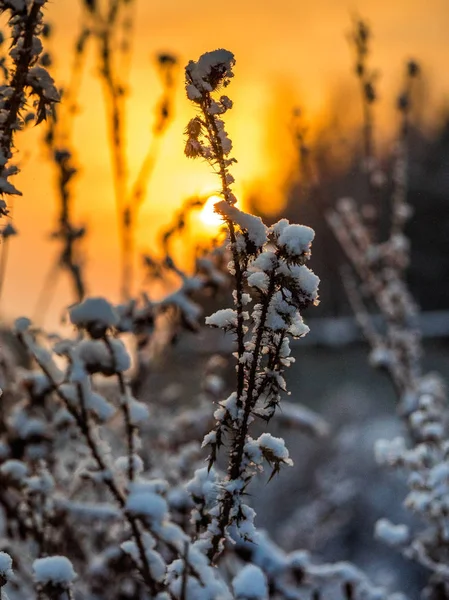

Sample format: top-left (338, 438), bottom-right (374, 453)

top-left (2, 0), bottom-right (449, 325)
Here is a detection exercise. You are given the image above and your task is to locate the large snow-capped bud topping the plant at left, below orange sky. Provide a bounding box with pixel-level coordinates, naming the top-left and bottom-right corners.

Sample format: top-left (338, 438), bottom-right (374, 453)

top-left (69, 298), bottom-right (119, 338)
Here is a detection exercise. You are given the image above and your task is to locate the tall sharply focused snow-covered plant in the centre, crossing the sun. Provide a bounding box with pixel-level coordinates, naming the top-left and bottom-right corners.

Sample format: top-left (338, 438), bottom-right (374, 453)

top-left (181, 50), bottom-right (319, 561)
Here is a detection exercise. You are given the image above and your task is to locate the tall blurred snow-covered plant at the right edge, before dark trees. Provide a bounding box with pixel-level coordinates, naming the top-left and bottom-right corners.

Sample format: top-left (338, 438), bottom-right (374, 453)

top-left (328, 61), bottom-right (449, 597)
